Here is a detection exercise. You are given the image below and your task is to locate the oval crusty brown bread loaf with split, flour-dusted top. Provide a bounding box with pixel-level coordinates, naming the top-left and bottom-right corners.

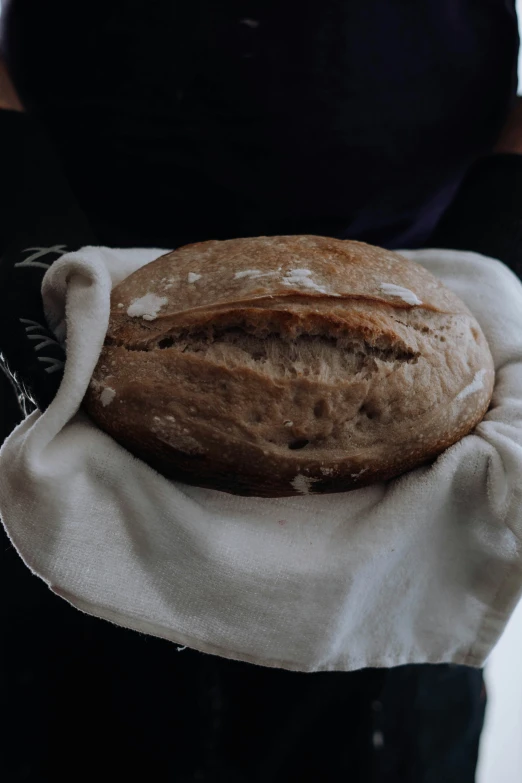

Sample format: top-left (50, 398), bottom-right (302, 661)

top-left (85, 236), bottom-right (494, 497)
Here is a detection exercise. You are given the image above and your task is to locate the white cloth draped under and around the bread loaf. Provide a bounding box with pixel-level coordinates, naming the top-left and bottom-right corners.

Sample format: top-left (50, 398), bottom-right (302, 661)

top-left (0, 247), bottom-right (522, 671)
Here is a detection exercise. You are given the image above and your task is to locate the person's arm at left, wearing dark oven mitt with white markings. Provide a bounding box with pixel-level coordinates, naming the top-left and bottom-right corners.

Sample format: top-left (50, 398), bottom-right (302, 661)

top-left (0, 56), bottom-right (96, 409)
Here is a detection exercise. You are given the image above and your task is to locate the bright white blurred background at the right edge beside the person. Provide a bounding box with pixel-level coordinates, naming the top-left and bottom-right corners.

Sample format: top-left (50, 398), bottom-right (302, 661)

top-left (0, 0), bottom-right (522, 783)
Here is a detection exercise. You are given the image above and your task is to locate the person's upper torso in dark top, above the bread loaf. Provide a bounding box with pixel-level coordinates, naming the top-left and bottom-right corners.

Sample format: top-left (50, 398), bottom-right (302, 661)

top-left (2, 0), bottom-right (518, 248)
